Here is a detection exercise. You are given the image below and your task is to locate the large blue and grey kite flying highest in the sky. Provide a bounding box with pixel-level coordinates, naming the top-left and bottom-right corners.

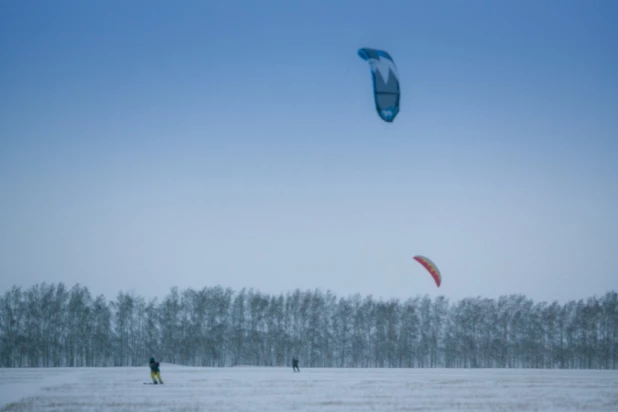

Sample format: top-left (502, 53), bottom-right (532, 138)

top-left (358, 48), bottom-right (400, 123)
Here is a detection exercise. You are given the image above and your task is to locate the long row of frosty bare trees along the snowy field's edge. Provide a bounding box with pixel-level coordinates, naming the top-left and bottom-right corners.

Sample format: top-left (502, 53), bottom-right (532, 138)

top-left (0, 283), bottom-right (618, 369)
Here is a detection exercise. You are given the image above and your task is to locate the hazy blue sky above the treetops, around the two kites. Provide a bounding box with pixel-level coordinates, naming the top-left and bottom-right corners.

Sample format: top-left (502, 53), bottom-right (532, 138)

top-left (0, 0), bottom-right (618, 300)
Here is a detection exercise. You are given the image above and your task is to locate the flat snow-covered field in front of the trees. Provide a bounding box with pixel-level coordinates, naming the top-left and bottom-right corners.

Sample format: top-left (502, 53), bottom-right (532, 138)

top-left (0, 364), bottom-right (618, 412)
